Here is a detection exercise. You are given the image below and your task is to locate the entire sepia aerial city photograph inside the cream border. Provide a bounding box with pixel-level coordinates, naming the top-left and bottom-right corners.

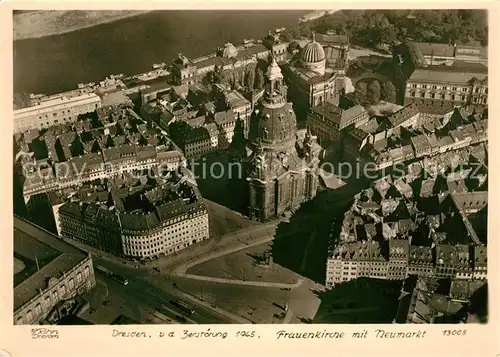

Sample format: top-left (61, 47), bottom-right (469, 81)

top-left (9, 9), bottom-right (488, 325)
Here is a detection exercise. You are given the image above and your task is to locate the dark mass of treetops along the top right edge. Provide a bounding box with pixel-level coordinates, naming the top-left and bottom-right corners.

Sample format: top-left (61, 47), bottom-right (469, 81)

top-left (290, 10), bottom-right (488, 47)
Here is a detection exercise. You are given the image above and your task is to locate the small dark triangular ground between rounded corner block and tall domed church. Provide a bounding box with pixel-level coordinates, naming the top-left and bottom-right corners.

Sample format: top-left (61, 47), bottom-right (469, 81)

top-left (206, 200), bottom-right (258, 237)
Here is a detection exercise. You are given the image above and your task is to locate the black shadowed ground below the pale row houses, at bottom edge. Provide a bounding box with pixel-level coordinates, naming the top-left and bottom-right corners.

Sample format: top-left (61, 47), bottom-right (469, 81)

top-left (313, 278), bottom-right (402, 323)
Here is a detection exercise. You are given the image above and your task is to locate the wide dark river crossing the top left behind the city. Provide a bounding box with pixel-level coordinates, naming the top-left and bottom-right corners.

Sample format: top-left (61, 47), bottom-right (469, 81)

top-left (14, 10), bottom-right (309, 94)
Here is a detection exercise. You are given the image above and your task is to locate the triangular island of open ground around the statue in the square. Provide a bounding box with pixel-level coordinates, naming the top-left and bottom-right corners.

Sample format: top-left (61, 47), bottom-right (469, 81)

top-left (187, 242), bottom-right (299, 284)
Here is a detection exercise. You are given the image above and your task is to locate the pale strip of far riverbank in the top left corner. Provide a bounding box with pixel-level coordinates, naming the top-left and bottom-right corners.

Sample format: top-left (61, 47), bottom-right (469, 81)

top-left (13, 10), bottom-right (149, 40)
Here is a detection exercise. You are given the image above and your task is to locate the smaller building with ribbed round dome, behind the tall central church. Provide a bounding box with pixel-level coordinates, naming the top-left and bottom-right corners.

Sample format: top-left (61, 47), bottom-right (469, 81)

top-left (286, 33), bottom-right (347, 113)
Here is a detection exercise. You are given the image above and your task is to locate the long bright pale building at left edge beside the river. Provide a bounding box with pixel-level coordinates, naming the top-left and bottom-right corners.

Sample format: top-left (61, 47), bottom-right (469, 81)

top-left (14, 93), bottom-right (102, 133)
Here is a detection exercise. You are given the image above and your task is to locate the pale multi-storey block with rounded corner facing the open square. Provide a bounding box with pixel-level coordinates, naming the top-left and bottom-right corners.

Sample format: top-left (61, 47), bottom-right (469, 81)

top-left (59, 178), bottom-right (209, 260)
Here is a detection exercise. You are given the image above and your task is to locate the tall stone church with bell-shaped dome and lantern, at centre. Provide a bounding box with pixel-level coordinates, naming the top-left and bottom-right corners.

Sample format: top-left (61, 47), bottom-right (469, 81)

top-left (233, 57), bottom-right (321, 221)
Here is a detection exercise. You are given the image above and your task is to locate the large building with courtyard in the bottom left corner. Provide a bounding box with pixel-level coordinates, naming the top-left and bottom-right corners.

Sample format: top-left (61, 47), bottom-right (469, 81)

top-left (14, 217), bottom-right (96, 325)
